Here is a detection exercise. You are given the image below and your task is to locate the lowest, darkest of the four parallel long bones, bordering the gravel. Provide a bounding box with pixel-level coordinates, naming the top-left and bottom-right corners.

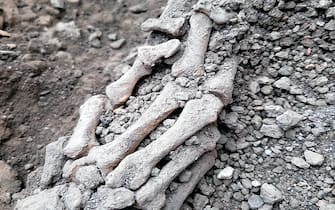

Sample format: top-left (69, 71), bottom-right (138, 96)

top-left (163, 151), bottom-right (216, 210)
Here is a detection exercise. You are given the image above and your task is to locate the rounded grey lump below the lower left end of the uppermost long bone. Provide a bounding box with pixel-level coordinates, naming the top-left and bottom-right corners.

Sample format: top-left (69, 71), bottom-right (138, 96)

top-left (76, 165), bottom-right (104, 189)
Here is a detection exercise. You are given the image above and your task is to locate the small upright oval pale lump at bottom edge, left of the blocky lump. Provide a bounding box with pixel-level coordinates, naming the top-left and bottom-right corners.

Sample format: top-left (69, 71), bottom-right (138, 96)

top-left (64, 183), bottom-right (82, 210)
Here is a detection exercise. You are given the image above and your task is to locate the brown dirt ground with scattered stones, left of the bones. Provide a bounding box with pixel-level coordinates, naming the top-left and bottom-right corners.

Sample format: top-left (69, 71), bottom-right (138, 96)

top-left (0, 0), bottom-right (164, 209)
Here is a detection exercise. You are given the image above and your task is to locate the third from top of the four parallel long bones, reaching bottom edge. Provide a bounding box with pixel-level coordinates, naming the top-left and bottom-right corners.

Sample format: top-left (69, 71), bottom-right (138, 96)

top-left (136, 125), bottom-right (220, 209)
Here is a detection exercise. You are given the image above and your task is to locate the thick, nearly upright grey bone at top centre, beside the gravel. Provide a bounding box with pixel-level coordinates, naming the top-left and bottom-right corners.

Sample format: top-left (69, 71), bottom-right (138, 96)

top-left (172, 13), bottom-right (212, 77)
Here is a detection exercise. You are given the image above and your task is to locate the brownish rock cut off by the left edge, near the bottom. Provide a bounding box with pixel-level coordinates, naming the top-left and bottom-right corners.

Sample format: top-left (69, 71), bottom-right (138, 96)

top-left (0, 160), bottom-right (21, 195)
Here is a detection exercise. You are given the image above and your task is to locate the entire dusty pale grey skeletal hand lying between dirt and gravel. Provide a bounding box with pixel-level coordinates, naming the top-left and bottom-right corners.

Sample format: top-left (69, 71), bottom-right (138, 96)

top-left (16, 0), bottom-right (237, 210)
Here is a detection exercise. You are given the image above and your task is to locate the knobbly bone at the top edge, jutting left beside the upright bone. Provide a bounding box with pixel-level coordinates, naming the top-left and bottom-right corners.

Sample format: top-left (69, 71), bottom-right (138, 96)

top-left (142, 0), bottom-right (192, 36)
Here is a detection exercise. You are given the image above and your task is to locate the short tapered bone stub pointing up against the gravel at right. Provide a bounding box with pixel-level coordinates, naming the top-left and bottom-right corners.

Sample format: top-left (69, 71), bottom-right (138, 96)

top-left (203, 59), bottom-right (237, 106)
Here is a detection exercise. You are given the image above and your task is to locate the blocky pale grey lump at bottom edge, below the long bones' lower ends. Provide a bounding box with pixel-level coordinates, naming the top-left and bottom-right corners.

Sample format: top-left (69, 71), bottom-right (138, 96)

top-left (97, 187), bottom-right (135, 209)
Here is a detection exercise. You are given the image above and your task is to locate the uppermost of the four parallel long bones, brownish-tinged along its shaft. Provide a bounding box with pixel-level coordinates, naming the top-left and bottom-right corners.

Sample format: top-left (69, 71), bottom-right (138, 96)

top-left (63, 83), bottom-right (194, 177)
